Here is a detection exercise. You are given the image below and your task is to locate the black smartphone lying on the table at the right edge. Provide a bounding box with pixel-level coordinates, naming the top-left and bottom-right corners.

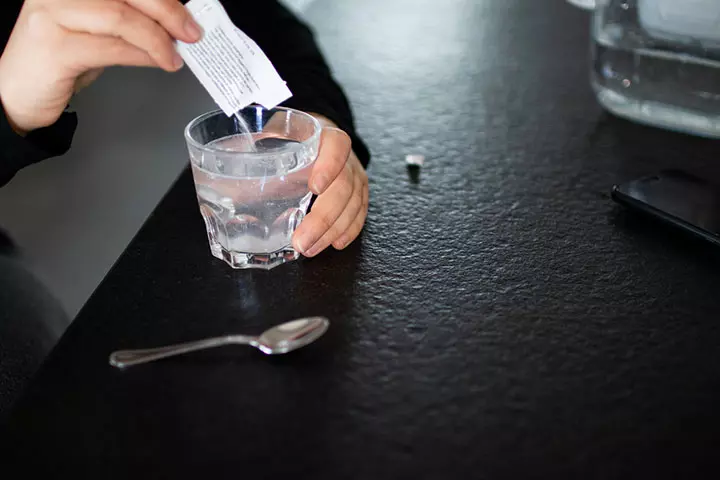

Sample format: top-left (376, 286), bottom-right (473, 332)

top-left (612, 170), bottom-right (720, 247)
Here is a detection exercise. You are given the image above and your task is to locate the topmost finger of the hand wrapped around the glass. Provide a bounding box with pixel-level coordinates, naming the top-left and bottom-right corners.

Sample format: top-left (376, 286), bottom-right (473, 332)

top-left (309, 127), bottom-right (352, 195)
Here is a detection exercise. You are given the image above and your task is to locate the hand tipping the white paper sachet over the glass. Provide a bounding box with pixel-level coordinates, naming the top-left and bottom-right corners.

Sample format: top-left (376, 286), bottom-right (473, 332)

top-left (0, 0), bottom-right (202, 134)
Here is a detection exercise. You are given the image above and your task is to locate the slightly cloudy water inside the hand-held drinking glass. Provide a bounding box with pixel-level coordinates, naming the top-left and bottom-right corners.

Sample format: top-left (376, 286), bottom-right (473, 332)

top-left (192, 133), bottom-right (314, 268)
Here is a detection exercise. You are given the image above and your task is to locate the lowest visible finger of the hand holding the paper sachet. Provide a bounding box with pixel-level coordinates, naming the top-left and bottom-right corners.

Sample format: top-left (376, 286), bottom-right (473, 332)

top-left (64, 33), bottom-right (157, 71)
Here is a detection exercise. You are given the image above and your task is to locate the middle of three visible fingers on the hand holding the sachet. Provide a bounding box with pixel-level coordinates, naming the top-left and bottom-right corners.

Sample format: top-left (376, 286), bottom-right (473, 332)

top-left (50, 0), bottom-right (182, 71)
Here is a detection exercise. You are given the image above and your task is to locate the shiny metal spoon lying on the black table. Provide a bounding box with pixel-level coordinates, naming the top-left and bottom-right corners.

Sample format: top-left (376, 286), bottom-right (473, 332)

top-left (110, 317), bottom-right (330, 368)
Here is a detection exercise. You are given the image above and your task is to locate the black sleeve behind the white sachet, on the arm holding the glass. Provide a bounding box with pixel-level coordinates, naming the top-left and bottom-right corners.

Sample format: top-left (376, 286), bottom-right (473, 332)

top-left (222, 0), bottom-right (370, 167)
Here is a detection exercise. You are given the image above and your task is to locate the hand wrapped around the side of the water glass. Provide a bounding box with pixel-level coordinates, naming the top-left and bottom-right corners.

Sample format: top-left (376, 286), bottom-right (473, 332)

top-left (293, 115), bottom-right (369, 257)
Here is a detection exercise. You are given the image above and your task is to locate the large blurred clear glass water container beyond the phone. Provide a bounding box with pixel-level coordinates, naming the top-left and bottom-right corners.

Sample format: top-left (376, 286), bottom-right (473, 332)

top-left (592, 0), bottom-right (720, 137)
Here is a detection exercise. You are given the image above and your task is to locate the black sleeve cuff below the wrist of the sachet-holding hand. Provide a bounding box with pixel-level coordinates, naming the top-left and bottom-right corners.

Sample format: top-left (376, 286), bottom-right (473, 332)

top-left (0, 108), bottom-right (77, 186)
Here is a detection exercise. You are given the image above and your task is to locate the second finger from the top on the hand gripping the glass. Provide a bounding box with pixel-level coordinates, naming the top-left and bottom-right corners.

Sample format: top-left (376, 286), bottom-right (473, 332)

top-left (293, 164), bottom-right (354, 255)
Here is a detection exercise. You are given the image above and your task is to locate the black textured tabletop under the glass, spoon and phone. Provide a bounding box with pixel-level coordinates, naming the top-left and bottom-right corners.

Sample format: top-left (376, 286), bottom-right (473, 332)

top-left (0, 0), bottom-right (720, 479)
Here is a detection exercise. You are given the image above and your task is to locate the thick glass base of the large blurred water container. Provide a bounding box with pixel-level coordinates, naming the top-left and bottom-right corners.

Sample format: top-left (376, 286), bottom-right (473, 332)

top-left (593, 82), bottom-right (720, 138)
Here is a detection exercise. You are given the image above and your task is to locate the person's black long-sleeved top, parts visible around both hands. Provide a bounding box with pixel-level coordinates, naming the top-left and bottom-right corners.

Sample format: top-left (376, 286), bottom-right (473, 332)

top-left (0, 0), bottom-right (370, 186)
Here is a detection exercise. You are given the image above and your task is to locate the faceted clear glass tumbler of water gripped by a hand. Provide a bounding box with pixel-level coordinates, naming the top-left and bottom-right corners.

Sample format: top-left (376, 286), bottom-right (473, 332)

top-left (185, 106), bottom-right (321, 269)
